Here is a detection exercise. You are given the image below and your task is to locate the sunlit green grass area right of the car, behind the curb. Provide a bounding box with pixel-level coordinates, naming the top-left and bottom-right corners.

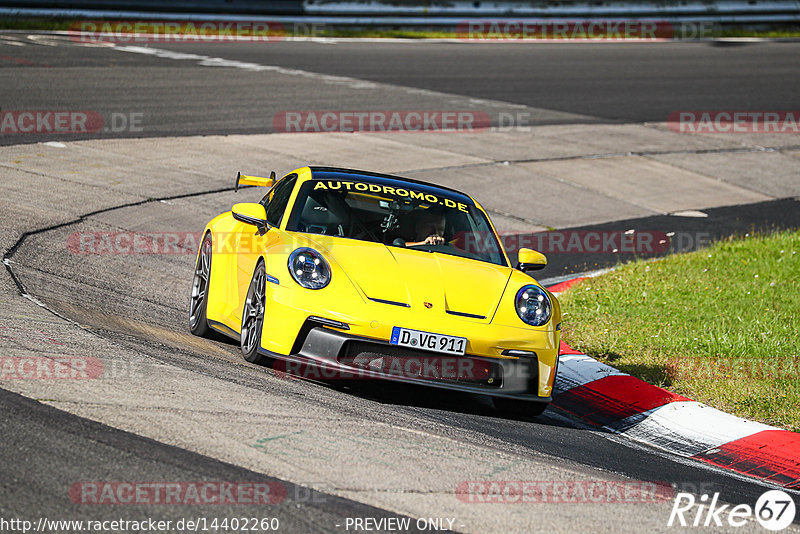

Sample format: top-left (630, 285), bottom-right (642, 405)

top-left (559, 231), bottom-right (800, 431)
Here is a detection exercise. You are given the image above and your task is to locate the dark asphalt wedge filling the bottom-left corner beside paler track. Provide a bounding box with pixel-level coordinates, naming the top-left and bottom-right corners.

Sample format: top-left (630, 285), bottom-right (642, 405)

top-left (0, 389), bottom-right (424, 532)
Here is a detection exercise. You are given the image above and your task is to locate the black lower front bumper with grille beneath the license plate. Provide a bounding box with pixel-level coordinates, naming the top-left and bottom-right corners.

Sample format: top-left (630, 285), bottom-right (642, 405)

top-left (261, 326), bottom-right (551, 402)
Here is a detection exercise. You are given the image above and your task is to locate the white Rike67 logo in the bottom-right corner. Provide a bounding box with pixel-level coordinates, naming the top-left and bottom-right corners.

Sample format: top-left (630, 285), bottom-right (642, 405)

top-left (667, 490), bottom-right (796, 531)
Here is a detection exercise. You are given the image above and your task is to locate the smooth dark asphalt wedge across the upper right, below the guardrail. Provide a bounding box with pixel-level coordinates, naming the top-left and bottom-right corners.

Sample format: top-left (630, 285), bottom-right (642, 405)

top-left (156, 43), bottom-right (800, 124)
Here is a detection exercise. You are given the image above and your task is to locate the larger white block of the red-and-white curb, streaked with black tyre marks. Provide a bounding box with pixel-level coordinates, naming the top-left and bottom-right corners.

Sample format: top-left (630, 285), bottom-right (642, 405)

top-left (620, 401), bottom-right (777, 456)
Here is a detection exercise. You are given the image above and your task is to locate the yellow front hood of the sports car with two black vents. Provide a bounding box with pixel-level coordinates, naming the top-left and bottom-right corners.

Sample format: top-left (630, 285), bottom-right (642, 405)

top-left (306, 238), bottom-right (512, 322)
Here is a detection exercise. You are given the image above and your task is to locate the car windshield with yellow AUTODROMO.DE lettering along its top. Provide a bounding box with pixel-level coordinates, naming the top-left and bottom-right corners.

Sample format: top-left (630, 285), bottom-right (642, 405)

top-left (286, 178), bottom-right (507, 266)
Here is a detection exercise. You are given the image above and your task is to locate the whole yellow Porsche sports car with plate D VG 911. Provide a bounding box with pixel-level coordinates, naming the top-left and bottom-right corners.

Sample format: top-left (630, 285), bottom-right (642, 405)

top-left (189, 167), bottom-right (561, 414)
